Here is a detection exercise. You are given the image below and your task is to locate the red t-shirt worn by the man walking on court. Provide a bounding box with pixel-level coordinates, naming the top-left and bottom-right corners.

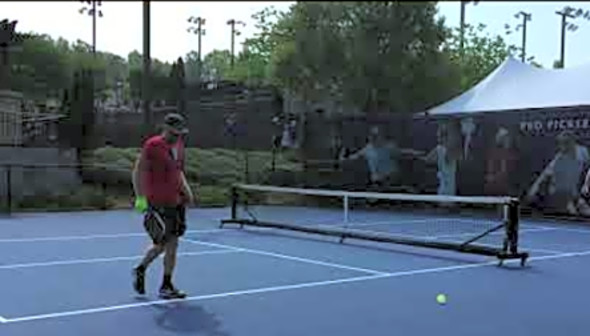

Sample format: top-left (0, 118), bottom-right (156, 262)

top-left (142, 135), bottom-right (184, 206)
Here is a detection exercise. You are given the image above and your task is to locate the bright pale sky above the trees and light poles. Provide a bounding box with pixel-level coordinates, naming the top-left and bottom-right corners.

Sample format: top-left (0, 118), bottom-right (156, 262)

top-left (0, 1), bottom-right (590, 67)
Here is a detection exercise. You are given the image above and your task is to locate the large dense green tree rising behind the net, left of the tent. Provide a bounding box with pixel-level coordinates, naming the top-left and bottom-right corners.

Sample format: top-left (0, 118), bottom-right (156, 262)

top-left (271, 2), bottom-right (452, 112)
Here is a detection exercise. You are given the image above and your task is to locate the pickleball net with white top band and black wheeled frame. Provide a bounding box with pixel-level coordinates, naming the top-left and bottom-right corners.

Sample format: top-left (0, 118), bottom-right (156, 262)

top-left (221, 184), bottom-right (528, 265)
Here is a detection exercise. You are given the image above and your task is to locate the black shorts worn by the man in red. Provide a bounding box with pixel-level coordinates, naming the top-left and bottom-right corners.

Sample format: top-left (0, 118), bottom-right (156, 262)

top-left (143, 205), bottom-right (186, 244)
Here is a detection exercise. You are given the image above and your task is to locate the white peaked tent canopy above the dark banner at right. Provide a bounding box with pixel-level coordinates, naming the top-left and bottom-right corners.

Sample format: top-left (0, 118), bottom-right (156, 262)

top-left (426, 57), bottom-right (590, 116)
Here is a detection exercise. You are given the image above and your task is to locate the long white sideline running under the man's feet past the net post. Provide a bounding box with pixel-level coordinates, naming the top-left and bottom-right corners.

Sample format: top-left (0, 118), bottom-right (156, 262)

top-left (4, 251), bottom-right (590, 323)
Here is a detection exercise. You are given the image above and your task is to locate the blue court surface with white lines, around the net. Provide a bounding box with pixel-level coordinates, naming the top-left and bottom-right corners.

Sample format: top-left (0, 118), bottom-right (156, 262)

top-left (0, 209), bottom-right (590, 336)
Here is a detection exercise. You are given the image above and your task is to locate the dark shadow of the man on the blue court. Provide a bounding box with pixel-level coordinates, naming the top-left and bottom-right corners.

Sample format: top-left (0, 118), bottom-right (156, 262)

top-left (142, 302), bottom-right (229, 336)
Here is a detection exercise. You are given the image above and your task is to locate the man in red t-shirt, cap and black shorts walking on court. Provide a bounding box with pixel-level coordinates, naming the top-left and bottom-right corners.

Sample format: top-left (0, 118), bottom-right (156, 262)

top-left (133, 113), bottom-right (194, 299)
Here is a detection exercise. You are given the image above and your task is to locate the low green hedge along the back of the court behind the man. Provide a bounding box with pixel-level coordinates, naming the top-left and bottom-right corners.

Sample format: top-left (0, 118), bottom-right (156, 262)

top-left (12, 147), bottom-right (301, 211)
